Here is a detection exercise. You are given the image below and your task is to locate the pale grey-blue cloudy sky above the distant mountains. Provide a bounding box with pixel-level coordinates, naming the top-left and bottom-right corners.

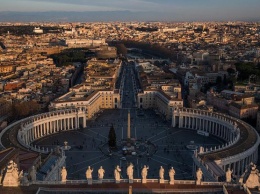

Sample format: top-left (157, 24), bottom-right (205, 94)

top-left (0, 0), bottom-right (260, 21)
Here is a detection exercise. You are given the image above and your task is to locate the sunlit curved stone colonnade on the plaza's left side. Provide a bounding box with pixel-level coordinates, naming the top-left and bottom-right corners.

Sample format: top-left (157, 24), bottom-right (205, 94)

top-left (17, 108), bottom-right (87, 153)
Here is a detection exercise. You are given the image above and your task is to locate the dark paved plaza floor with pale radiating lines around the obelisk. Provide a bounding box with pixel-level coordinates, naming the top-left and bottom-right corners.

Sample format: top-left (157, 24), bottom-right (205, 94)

top-left (33, 109), bottom-right (223, 180)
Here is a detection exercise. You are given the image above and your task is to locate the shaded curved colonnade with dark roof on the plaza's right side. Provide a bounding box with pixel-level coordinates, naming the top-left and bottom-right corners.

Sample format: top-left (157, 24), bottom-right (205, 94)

top-left (172, 108), bottom-right (260, 179)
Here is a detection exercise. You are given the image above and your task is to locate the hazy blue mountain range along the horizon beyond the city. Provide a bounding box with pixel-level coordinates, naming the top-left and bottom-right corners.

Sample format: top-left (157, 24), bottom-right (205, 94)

top-left (0, 10), bottom-right (260, 22)
